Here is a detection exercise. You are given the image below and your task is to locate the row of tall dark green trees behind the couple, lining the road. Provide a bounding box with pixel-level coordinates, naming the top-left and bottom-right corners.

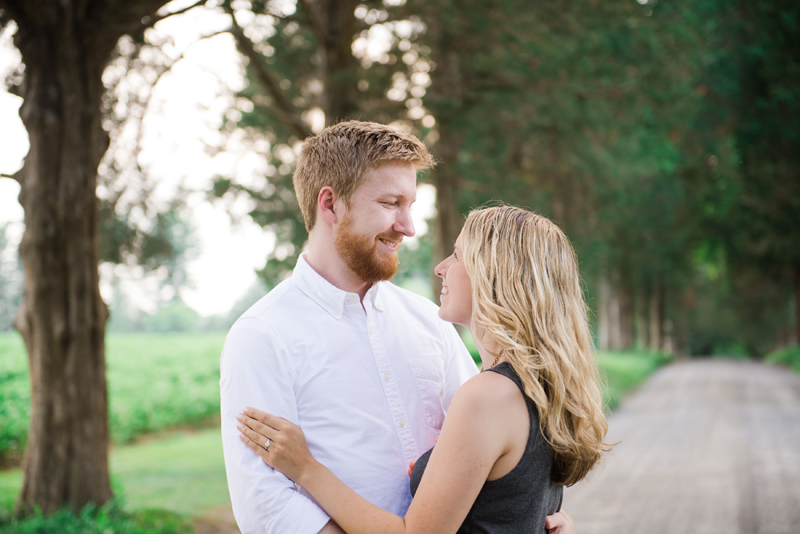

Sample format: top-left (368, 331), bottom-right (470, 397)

top-left (214, 0), bottom-right (800, 354)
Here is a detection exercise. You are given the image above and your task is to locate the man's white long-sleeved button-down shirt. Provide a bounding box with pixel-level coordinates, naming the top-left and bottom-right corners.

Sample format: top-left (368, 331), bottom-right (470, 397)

top-left (220, 257), bottom-right (477, 534)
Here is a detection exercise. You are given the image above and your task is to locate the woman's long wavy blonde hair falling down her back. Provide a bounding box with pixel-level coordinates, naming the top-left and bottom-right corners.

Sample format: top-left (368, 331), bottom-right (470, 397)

top-left (461, 206), bottom-right (610, 486)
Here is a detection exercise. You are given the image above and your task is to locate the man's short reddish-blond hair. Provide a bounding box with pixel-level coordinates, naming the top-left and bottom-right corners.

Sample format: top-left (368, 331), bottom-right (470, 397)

top-left (293, 121), bottom-right (434, 232)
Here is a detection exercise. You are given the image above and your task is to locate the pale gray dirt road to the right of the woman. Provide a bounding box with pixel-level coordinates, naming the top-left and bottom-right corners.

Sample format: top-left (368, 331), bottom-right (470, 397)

top-left (564, 360), bottom-right (800, 534)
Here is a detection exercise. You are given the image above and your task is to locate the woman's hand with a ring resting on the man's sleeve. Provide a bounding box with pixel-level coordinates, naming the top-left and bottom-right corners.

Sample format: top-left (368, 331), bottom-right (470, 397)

top-left (236, 408), bottom-right (316, 485)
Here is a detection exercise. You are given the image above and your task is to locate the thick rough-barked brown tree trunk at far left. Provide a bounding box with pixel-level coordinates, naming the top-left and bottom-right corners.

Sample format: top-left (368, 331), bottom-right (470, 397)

top-left (0, 0), bottom-right (172, 513)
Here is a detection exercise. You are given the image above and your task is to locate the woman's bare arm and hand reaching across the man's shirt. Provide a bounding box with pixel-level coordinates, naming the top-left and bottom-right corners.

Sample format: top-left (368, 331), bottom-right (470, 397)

top-left (236, 373), bottom-right (527, 534)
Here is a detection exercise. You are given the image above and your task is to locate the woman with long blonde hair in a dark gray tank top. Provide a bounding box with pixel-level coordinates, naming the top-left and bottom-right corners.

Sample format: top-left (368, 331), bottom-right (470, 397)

top-left (234, 206), bottom-right (608, 534)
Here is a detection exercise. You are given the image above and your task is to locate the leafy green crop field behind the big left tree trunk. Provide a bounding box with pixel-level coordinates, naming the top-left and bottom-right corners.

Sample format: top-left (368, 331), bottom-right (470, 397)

top-left (0, 332), bottom-right (225, 456)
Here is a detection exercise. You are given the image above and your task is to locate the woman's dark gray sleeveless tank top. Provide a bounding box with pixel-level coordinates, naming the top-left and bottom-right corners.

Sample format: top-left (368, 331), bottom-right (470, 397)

top-left (411, 362), bottom-right (564, 534)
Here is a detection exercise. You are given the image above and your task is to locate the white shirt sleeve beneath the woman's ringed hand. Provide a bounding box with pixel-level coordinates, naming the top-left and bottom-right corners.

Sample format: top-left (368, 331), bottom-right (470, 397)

top-left (220, 317), bottom-right (330, 534)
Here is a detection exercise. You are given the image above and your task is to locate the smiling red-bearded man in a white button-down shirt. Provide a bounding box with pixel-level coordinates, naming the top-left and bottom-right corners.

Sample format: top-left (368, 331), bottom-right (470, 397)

top-left (220, 121), bottom-right (568, 534)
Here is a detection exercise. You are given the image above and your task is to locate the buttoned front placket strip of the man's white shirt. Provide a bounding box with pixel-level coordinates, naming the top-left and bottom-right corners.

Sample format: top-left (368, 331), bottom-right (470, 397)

top-left (367, 311), bottom-right (420, 463)
